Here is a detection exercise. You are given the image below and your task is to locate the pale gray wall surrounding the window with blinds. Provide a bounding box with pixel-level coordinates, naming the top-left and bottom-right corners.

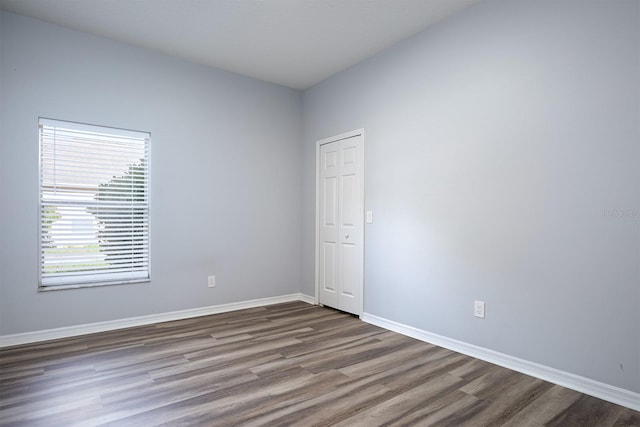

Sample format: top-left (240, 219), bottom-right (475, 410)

top-left (0, 13), bottom-right (302, 335)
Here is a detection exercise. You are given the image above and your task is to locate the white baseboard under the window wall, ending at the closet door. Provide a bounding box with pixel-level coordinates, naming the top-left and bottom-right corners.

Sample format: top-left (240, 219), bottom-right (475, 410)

top-left (0, 293), bottom-right (315, 348)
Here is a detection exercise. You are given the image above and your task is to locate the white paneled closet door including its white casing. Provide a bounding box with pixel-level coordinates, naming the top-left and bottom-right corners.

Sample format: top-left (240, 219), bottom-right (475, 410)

top-left (316, 130), bottom-right (364, 315)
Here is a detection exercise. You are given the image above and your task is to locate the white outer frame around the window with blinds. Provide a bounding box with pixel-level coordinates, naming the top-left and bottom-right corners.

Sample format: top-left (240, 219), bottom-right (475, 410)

top-left (37, 117), bottom-right (151, 292)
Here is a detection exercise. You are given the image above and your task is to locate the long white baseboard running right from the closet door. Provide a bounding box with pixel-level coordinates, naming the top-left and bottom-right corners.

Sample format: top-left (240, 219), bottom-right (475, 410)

top-left (360, 313), bottom-right (640, 411)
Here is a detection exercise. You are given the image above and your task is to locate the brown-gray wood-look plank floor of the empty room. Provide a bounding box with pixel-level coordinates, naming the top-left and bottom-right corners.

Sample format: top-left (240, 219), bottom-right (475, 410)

top-left (0, 302), bottom-right (640, 427)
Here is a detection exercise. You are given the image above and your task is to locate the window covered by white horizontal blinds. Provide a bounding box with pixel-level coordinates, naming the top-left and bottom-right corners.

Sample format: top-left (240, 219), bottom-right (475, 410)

top-left (39, 119), bottom-right (150, 289)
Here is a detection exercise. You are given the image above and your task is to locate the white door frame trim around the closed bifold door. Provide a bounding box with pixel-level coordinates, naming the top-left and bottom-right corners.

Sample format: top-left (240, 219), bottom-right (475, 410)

top-left (314, 128), bottom-right (365, 315)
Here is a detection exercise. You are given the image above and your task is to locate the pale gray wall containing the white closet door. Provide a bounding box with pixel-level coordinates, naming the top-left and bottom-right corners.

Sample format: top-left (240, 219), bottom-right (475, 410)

top-left (303, 0), bottom-right (640, 392)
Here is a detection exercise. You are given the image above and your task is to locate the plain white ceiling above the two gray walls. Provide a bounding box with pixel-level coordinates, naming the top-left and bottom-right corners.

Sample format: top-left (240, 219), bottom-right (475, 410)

top-left (0, 0), bottom-right (479, 89)
